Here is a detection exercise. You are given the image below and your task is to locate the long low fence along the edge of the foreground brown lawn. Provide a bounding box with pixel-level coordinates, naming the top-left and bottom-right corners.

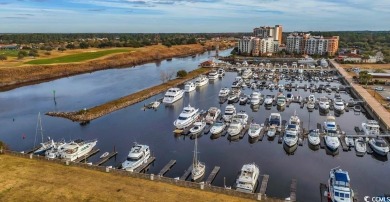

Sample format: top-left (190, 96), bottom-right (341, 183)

top-left (0, 150), bottom-right (272, 201)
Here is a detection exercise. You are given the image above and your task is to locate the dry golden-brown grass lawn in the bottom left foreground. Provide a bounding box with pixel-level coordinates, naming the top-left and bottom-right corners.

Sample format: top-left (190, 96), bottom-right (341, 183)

top-left (0, 155), bottom-right (253, 202)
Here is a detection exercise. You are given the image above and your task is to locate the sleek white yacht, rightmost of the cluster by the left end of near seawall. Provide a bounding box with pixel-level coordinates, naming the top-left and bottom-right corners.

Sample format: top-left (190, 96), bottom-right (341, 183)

top-left (60, 140), bottom-right (97, 161)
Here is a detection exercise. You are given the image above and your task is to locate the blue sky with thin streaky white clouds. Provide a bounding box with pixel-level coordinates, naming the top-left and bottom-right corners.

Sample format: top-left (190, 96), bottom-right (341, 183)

top-left (0, 0), bottom-right (390, 33)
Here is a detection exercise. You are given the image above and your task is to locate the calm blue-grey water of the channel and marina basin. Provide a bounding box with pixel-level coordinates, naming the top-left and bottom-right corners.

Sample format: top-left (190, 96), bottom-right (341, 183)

top-left (0, 52), bottom-right (390, 201)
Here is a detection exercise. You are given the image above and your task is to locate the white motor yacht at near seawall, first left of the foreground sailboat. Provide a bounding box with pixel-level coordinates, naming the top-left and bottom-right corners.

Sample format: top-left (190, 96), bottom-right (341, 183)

top-left (122, 143), bottom-right (151, 171)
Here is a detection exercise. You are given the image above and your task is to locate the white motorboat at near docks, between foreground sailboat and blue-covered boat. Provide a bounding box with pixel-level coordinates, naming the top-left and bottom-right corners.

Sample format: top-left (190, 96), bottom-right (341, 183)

top-left (236, 163), bottom-right (260, 193)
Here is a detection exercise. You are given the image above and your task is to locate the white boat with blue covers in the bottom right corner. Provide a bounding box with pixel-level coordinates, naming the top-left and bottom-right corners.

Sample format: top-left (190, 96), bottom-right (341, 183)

top-left (328, 168), bottom-right (354, 202)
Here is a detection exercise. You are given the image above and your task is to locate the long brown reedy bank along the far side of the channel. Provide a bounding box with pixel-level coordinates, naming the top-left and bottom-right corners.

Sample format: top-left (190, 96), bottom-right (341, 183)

top-left (0, 43), bottom-right (229, 92)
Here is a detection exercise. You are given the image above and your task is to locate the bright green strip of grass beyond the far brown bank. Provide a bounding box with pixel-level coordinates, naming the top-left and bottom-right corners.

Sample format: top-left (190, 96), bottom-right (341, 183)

top-left (25, 49), bottom-right (131, 65)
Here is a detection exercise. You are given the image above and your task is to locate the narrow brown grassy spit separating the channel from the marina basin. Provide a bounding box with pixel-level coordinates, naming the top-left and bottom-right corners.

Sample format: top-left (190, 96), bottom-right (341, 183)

top-left (46, 68), bottom-right (210, 123)
